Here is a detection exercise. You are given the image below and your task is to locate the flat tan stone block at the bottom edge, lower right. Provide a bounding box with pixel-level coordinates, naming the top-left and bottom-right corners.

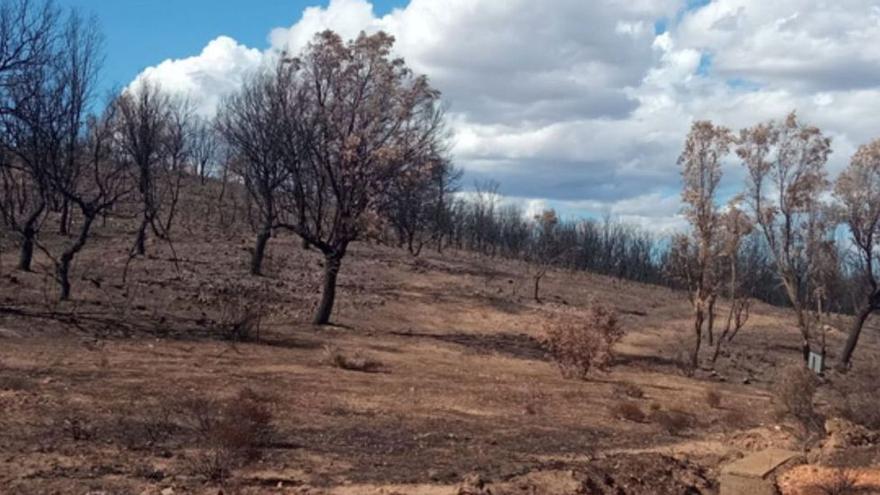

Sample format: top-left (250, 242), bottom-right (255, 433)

top-left (720, 448), bottom-right (802, 495)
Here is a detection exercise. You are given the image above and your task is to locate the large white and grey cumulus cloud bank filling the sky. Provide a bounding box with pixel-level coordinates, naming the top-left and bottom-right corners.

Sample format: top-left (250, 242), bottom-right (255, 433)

top-left (129, 0), bottom-right (880, 232)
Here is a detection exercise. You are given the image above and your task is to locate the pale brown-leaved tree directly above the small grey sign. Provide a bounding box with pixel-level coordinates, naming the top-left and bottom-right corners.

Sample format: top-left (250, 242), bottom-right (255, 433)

top-left (736, 112), bottom-right (831, 362)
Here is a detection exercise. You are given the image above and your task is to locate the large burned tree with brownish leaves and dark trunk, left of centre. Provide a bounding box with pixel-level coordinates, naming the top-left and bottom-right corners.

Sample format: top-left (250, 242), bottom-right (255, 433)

top-left (278, 31), bottom-right (444, 325)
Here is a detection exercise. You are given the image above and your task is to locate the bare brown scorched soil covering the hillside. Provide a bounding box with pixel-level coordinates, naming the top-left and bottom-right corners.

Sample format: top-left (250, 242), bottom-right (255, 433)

top-left (0, 192), bottom-right (880, 495)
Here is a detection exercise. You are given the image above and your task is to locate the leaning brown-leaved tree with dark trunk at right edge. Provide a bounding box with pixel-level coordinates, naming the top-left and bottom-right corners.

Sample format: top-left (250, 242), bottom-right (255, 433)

top-left (834, 140), bottom-right (880, 368)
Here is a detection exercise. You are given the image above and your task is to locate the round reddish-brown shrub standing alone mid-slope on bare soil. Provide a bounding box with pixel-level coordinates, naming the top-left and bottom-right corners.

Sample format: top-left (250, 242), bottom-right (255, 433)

top-left (545, 304), bottom-right (624, 379)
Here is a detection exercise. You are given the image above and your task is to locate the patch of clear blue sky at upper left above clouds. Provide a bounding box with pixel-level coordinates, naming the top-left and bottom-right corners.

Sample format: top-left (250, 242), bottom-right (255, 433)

top-left (56, 0), bottom-right (406, 93)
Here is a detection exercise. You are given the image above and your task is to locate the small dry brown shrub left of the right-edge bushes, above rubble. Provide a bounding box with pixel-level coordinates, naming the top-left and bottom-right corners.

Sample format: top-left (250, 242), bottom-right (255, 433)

top-left (773, 365), bottom-right (822, 434)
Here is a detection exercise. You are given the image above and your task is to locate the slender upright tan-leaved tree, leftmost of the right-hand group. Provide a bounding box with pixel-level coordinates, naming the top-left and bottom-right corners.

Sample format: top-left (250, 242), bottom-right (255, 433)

top-left (678, 121), bottom-right (733, 369)
